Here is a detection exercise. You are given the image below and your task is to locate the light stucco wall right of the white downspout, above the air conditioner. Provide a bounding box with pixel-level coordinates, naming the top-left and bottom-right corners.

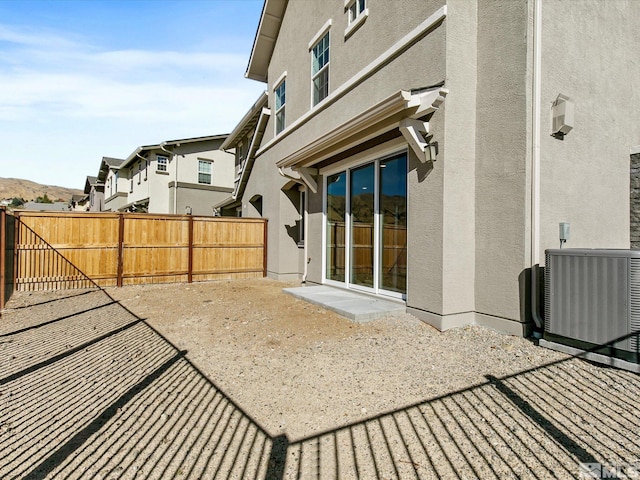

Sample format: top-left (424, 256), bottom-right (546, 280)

top-left (540, 0), bottom-right (640, 255)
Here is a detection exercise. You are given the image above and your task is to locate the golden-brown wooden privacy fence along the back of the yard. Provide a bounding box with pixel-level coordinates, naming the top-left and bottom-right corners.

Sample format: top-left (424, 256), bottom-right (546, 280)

top-left (15, 212), bottom-right (267, 291)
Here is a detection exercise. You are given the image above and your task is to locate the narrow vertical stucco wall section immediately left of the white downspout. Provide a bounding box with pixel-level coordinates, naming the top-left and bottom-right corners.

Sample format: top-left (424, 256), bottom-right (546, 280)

top-left (475, 0), bottom-right (530, 320)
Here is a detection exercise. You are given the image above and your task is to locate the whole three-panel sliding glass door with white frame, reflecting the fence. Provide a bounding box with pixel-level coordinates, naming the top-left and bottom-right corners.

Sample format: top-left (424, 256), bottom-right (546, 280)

top-left (325, 153), bottom-right (407, 296)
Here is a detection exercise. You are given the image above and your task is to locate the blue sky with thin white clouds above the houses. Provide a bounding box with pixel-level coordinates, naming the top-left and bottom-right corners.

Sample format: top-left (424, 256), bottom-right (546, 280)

top-left (0, 0), bottom-right (265, 188)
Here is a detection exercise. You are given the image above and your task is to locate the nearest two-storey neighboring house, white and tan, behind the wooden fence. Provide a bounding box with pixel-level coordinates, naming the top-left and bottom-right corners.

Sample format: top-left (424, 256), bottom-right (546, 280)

top-left (118, 135), bottom-right (234, 216)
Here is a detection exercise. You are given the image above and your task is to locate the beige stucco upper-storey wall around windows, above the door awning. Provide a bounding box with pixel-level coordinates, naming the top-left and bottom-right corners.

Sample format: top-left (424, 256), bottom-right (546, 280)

top-left (262, 1), bottom-right (445, 158)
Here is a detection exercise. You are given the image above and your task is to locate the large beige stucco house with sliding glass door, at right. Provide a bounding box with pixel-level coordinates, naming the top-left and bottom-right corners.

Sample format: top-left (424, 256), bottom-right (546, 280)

top-left (234, 0), bottom-right (640, 335)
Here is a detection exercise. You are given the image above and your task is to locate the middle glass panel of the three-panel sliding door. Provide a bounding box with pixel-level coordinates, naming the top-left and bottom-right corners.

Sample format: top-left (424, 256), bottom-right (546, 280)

top-left (350, 163), bottom-right (375, 287)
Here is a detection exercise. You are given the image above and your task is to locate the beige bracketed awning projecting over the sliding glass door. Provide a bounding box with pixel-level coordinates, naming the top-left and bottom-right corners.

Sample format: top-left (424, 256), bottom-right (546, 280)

top-left (276, 87), bottom-right (449, 171)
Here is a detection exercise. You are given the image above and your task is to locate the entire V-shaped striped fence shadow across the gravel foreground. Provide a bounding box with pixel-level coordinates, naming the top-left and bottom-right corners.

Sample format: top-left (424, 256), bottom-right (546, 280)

top-left (0, 232), bottom-right (640, 479)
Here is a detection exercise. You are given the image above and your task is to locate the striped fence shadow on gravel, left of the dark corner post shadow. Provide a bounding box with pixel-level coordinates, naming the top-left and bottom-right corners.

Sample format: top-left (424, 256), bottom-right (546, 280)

top-left (0, 291), bottom-right (283, 479)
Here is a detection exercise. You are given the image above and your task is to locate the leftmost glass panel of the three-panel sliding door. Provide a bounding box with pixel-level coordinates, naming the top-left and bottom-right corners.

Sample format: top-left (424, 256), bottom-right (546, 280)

top-left (326, 172), bottom-right (347, 282)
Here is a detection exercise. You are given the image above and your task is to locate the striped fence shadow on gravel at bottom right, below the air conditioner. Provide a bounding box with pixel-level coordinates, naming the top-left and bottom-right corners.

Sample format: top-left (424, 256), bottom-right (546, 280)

top-left (284, 333), bottom-right (640, 479)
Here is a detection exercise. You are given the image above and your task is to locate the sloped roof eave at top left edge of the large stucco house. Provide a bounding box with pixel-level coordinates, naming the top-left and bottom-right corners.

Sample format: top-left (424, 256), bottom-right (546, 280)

top-left (244, 0), bottom-right (288, 82)
